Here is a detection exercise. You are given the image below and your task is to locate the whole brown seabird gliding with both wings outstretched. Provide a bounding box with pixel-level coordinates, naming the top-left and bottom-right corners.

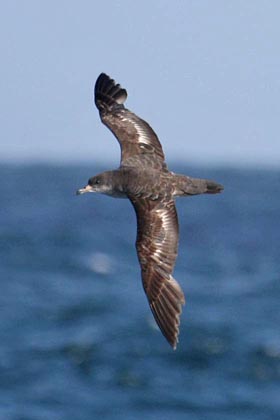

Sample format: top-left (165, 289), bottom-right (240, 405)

top-left (77, 73), bottom-right (223, 349)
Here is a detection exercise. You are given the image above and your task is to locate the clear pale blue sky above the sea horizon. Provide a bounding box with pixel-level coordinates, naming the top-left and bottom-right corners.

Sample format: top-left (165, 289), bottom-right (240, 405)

top-left (0, 0), bottom-right (280, 167)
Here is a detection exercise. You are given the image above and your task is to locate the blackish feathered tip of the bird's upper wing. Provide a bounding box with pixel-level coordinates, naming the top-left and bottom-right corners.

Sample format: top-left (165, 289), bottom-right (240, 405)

top-left (94, 73), bottom-right (127, 111)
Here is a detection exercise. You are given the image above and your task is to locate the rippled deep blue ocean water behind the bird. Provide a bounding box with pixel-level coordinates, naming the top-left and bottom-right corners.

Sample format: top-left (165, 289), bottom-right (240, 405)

top-left (0, 164), bottom-right (280, 420)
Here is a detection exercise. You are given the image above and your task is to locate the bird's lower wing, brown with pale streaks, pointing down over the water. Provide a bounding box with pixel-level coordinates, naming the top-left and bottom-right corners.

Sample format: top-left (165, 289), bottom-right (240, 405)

top-left (130, 197), bottom-right (185, 349)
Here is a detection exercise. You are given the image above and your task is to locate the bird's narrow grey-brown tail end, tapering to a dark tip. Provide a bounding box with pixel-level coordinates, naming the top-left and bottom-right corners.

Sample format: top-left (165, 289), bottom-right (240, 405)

top-left (174, 175), bottom-right (224, 196)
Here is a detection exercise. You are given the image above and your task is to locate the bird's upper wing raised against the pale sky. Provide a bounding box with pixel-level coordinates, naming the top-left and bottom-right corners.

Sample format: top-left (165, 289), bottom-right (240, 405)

top-left (94, 73), bottom-right (166, 169)
